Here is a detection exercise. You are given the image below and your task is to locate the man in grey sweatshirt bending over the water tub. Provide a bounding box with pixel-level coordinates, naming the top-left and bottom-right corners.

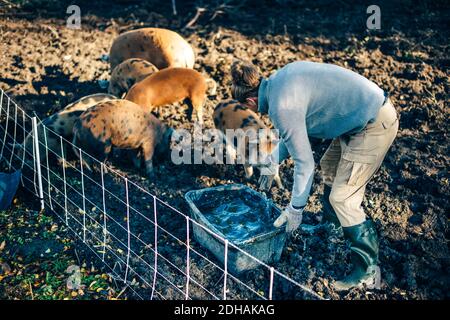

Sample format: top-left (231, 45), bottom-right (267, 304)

top-left (231, 61), bottom-right (398, 290)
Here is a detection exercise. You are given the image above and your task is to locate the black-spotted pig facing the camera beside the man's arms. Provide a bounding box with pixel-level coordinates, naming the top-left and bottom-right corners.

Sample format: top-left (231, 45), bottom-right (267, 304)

top-left (213, 100), bottom-right (282, 188)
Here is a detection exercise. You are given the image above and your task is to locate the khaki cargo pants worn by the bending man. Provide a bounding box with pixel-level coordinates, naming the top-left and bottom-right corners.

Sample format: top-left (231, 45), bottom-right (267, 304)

top-left (320, 99), bottom-right (398, 227)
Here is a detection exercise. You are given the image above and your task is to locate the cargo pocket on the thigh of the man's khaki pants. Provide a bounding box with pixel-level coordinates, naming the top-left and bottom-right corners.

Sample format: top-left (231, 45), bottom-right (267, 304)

top-left (342, 152), bottom-right (377, 186)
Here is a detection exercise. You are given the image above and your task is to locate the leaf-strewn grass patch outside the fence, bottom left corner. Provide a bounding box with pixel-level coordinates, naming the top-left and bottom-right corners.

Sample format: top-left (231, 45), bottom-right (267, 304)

top-left (0, 192), bottom-right (123, 300)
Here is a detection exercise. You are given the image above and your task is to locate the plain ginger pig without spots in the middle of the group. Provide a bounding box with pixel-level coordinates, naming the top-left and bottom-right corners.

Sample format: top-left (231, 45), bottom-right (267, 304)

top-left (125, 68), bottom-right (215, 124)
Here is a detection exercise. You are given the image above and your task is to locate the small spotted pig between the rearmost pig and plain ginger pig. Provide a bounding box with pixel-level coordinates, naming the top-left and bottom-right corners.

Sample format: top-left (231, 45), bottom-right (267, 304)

top-left (108, 58), bottom-right (158, 98)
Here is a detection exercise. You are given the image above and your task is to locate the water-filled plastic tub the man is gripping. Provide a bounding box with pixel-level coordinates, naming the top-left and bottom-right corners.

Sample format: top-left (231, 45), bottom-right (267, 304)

top-left (185, 185), bottom-right (286, 274)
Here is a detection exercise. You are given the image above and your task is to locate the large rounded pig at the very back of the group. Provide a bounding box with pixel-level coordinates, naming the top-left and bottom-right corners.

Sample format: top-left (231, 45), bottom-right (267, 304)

top-left (109, 28), bottom-right (195, 70)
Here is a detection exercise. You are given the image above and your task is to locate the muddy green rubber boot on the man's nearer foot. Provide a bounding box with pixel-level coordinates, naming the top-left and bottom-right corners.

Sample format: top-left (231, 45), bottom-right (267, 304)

top-left (334, 220), bottom-right (381, 291)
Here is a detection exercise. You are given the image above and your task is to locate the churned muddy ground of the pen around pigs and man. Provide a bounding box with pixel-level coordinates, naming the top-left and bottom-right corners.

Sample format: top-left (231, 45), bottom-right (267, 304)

top-left (0, 0), bottom-right (450, 299)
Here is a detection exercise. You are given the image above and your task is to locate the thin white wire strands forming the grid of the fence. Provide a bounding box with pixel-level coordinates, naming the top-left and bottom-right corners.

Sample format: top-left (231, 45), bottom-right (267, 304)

top-left (0, 89), bottom-right (323, 299)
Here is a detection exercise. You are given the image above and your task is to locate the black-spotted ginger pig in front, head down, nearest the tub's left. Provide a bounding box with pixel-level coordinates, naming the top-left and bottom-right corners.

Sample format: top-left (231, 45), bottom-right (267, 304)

top-left (73, 99), bottom-right (173, 176)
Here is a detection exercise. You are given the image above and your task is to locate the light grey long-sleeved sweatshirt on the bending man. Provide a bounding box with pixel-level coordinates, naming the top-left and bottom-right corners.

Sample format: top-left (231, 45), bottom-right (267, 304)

top-left (258, 61), bottom-right (384, 207)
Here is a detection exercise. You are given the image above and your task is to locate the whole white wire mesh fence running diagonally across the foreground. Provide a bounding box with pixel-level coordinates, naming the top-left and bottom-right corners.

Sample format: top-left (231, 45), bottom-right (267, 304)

top-left (0, 90), bottom-right (322, 300)
